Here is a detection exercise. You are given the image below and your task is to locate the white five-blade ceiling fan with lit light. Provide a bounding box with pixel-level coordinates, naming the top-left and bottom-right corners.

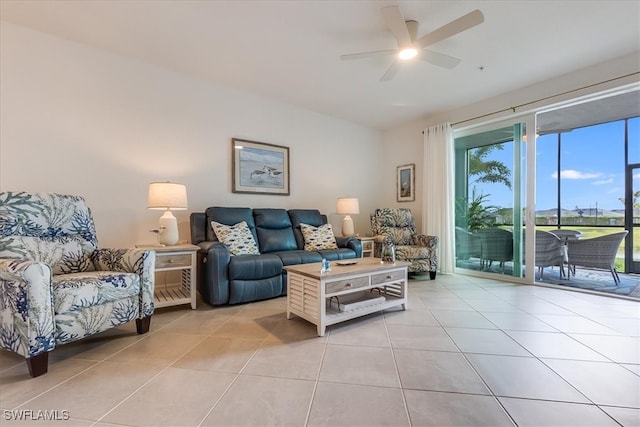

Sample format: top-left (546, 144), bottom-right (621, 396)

top-left (340, 6), bottom-right (484, 82)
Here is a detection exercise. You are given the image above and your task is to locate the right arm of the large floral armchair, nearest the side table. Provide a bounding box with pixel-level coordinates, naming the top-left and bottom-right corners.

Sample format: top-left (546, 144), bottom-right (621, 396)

top-left (91, 248), bottom-right (156, 319)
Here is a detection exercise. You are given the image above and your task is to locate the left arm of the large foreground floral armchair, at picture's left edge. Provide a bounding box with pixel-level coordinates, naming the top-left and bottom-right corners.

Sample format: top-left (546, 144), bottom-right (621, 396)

top-left (0, 258), bottom-right (55, 358)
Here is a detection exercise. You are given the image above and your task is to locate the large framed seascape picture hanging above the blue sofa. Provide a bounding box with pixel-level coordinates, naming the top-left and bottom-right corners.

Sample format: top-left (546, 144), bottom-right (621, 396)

top-left (231, 138), bottom-right (290, 196)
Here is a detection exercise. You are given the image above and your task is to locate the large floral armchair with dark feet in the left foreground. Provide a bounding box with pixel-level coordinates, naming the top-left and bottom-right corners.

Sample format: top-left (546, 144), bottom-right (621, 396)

top-left (0, 192), bottom-right (155, 377)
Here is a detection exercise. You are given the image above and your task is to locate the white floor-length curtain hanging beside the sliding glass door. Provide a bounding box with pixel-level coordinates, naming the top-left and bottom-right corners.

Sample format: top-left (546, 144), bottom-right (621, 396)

top-left (422, 123), bottom-right (455, 274)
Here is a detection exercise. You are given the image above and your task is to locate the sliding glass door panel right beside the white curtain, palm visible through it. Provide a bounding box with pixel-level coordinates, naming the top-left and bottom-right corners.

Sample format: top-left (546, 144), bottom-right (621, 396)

top-left (455, 122), bottom-right (527, 277)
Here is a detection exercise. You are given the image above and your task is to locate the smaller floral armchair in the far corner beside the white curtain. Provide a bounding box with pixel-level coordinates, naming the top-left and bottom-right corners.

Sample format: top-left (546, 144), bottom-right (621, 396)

top-left (370, 208), bottom-right (439, 280)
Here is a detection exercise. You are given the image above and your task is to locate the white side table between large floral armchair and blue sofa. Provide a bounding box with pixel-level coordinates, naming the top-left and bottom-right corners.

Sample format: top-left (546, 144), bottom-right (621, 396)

top-left (136, 244), bottom-right (200, 310)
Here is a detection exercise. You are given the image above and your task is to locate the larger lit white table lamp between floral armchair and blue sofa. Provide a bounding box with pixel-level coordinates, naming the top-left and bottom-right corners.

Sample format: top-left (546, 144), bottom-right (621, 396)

top-left (147, 181), bottom-right (187, 246)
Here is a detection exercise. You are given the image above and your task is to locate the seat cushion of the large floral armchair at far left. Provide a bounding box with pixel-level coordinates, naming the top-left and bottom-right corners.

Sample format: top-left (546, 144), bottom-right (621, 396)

top-left (51, 271), bottom-right (140, 314)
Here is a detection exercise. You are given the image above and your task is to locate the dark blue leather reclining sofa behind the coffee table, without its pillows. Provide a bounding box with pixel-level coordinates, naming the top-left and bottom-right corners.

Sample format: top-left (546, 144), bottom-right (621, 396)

top-left (190, 207), bottom-right (362, 305)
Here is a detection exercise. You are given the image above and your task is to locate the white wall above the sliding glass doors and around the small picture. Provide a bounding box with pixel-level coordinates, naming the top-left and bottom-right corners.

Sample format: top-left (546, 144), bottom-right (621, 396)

top-left (384, 52), bottom-right (640, 234)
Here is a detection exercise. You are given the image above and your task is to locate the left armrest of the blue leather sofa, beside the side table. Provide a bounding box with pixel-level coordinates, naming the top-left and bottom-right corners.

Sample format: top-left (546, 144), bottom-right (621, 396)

top-left (197, 241), bottom-right (231, 305)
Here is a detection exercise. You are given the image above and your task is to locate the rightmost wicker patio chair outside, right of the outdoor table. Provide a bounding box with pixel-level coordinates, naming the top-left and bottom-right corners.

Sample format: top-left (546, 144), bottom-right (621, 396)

top-left (567, 230), bottom-right (629, 285)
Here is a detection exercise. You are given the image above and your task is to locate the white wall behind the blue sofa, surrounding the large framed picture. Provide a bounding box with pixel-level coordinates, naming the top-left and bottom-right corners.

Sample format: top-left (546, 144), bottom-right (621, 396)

top-left (0, 22), bottom-right (384, 247)
